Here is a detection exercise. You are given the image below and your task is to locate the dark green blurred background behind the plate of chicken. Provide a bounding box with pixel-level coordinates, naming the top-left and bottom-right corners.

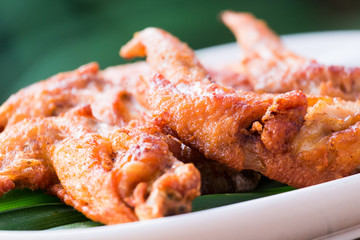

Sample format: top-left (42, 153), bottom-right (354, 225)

top-left (0, 0), bottom-right (360, 102)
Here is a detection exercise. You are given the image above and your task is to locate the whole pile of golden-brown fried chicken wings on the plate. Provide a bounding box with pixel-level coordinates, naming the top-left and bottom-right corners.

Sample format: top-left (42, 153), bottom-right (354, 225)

top-left (0, 11), bottom-right (360, 224)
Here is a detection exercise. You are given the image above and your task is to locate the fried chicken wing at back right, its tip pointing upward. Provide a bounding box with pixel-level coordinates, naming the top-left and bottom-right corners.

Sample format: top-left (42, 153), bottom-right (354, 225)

top-left (221, 11), bottom-right (360, 100)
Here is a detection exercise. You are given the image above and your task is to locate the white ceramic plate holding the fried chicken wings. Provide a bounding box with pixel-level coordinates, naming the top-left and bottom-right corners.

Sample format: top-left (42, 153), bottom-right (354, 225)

top-left (0, 31), bottom-right (360, 240)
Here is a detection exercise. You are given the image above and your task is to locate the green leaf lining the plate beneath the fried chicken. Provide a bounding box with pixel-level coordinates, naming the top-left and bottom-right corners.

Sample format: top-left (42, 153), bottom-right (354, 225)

top-left (0, 178), bottom-right (294, 230)
